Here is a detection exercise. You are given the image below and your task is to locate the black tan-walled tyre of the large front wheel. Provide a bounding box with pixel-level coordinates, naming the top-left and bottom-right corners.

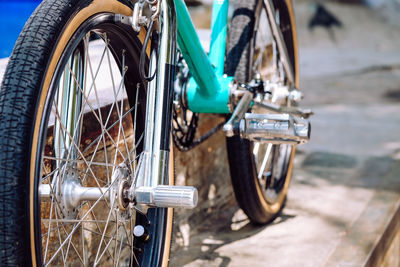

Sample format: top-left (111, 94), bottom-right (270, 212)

top-left (0, 0), bottom-right (172, 266)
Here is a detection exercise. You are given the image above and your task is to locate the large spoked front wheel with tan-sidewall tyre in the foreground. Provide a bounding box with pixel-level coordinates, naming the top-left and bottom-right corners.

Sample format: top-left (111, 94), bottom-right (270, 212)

top-left (0, 0), bottom-right (173, 266)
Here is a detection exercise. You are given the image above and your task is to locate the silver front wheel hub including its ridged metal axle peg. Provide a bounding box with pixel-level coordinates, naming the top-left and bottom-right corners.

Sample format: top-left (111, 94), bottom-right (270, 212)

top-left (39, 164), bottom-right (198, 215)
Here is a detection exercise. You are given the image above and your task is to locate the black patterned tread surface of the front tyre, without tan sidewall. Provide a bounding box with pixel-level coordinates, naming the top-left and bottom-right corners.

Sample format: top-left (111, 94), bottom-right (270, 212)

top-left (0, 0), bottom-right (87, 266)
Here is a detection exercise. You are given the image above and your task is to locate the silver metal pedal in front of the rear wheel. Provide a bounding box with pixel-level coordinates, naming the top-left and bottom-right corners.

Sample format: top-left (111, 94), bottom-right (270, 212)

top-left (228, 113), bottom-right (311, 144)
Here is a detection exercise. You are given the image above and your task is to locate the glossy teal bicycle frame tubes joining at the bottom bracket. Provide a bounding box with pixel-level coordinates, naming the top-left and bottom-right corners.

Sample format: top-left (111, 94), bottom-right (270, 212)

top-left (174, 0), bottom-right (233, 113)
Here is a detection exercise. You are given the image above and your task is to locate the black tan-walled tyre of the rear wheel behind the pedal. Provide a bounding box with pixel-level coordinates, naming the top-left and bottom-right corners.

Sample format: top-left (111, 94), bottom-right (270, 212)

top-left (226, 0), bottom-right (297, 224)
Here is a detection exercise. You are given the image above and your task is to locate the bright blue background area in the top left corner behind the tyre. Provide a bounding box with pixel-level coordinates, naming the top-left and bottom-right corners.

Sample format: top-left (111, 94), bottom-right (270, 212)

top-left (0, 0), bottom-right (41, 58)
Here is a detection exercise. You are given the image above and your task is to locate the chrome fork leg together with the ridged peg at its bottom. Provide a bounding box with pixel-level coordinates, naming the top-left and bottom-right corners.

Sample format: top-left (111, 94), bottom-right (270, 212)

top-left (128, 0), bottom-right (198, 211)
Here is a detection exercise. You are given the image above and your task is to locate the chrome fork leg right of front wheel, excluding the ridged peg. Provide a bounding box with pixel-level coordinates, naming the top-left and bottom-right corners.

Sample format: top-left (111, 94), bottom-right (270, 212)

top-left (136, 0), bottom-right (176, 191)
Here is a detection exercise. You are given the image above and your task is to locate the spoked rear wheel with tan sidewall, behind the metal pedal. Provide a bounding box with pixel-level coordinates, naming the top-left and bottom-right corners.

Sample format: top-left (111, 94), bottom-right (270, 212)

top-left (226, 0), bottom-right (298, 224)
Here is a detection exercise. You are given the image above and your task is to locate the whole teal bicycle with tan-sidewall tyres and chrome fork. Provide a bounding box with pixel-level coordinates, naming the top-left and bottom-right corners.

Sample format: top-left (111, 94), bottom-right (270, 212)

top-left (0, 0), bottom-right (311, 266)
